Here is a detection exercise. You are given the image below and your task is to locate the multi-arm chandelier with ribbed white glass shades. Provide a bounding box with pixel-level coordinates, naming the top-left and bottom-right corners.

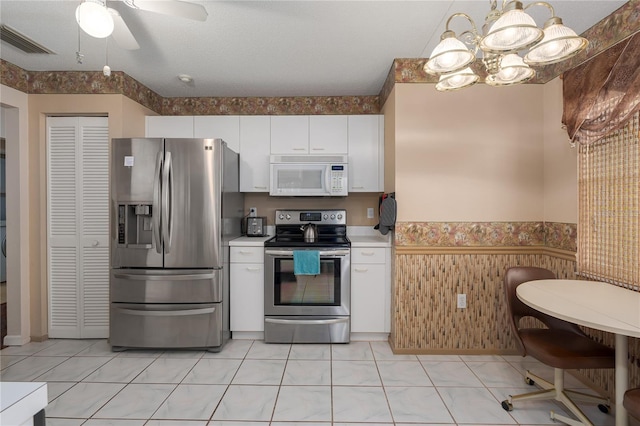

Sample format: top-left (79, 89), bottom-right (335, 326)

top-left (424, 0), bottom-right (588, 91)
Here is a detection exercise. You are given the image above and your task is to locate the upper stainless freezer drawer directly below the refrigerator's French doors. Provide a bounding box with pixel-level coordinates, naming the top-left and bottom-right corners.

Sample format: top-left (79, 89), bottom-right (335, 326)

top-left (110, 269), bottom-right (223, 303)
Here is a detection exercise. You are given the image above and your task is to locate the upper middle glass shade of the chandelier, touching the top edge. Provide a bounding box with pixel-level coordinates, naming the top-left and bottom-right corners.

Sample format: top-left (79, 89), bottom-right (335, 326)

top-left (480, 1), bottom-right (544, 53)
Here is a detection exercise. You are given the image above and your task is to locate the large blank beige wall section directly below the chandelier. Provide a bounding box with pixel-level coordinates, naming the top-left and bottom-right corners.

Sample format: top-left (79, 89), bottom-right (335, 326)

top-left (395, 83), bottom-right (544, 222)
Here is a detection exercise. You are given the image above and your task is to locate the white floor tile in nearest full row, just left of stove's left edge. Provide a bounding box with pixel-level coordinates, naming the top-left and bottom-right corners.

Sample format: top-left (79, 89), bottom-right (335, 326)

top-left (213, 385), bottom-right (279, 421)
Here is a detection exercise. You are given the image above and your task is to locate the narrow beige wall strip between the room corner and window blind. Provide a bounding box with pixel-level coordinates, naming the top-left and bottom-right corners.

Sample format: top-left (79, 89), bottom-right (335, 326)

top-left (544, 78), bottom-right (578, 223)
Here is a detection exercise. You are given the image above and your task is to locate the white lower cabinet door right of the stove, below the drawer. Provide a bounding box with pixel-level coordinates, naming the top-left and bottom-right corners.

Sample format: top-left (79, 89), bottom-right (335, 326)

top-left (351, 263), bottom-right (389, 333)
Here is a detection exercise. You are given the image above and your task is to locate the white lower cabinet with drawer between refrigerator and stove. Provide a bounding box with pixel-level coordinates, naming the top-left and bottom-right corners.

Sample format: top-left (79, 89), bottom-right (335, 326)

top-left (229, 245), bottom-right (264, 333)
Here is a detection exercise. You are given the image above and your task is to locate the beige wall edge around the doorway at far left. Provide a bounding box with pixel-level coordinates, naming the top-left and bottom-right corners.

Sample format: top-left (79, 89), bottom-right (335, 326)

top-left (0, 85), bottom-right (31, 345)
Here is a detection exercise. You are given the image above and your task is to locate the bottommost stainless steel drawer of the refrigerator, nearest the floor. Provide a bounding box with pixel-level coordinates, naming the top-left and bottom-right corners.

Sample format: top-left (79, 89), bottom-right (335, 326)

top-left (109, 303), bottom-right (223, 350)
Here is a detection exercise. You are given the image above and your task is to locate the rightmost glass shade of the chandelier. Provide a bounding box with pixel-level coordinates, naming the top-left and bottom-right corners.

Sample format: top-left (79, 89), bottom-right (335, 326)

top-left (524, 17), bottom-right (589, 65)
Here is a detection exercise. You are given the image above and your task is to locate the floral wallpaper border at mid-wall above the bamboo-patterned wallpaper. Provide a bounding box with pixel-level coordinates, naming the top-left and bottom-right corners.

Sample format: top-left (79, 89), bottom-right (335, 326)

top-left (395, 222), bottom-right (577, 252)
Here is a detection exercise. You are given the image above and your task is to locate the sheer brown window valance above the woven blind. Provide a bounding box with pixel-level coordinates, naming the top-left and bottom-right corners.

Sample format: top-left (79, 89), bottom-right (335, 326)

top-left (562, 33), bottom-right (640, 144)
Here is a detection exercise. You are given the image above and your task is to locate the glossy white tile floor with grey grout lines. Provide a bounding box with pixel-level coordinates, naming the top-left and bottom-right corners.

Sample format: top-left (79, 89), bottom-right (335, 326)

top-left (0, 339), bottom-right (615, 426)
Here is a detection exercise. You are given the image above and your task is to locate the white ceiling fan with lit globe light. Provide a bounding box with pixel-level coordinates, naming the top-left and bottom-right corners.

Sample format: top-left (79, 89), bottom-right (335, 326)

top-left (76, 0), bottom-right (208, 50)
